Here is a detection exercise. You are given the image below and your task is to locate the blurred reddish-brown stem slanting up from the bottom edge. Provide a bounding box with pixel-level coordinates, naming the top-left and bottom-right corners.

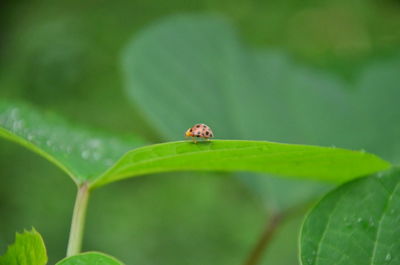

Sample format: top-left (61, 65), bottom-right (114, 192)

top-left (244, 213), bottom-right (284, 265)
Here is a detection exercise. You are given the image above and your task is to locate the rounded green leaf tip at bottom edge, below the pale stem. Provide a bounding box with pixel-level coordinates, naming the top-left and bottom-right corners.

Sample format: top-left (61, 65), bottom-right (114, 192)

top-left (56, 252), bottom-right (123, 265)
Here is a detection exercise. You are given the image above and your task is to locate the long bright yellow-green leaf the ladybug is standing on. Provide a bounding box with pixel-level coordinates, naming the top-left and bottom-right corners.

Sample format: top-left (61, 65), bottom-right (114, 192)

top-left (94, 140), bottom-right (390, 186)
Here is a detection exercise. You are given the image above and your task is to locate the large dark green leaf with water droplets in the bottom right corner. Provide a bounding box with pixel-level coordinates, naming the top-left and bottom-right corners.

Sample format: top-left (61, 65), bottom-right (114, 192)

top-left (300, 169), bottom-right (400, 265)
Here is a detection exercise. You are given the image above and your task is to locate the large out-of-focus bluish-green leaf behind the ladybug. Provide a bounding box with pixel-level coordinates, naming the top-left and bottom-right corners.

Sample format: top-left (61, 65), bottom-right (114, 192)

top-left (122, 15), bottom-right (400, 209)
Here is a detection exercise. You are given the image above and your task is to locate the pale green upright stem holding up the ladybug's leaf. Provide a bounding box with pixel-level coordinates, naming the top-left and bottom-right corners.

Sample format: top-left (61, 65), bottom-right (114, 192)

top-left (67, 182), bottom-right (89, 257)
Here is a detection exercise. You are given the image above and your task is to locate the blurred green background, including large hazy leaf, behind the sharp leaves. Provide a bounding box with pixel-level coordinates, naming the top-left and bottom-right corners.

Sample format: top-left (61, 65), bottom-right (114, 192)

top-left (0, 0), bottom-right (400, 265)
